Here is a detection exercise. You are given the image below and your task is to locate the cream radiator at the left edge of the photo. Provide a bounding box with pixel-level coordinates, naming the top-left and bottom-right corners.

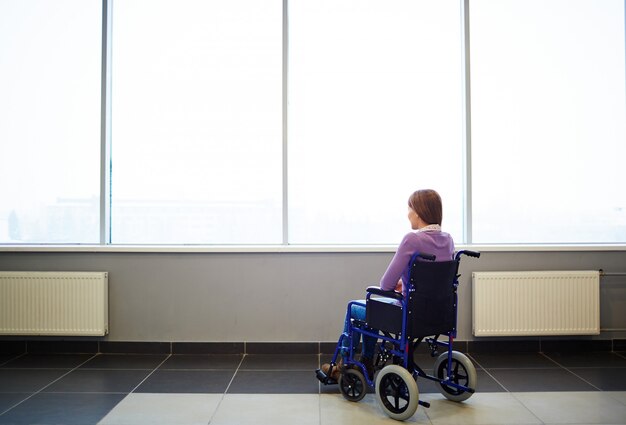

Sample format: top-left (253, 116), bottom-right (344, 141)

top-left (0, 272), bottom-right (109, 336)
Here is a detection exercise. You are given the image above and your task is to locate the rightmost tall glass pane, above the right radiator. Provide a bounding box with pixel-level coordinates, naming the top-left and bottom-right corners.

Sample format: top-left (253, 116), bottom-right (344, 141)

top-left (470, 0), bottom-right (626, 243)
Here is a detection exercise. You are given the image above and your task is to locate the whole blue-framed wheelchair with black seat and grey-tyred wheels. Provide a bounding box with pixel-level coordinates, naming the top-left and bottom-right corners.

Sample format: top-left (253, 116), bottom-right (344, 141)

top-left (316, 250), bottom-right (480, 421)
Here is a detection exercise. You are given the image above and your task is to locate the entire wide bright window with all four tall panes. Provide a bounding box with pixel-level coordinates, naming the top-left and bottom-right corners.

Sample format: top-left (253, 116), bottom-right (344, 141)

top-left (0, 0), bottom-right (626, 245)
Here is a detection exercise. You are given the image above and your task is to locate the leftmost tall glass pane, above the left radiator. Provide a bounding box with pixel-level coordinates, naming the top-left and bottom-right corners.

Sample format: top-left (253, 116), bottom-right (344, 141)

top-left (0, 0), bottom-right (102, 243)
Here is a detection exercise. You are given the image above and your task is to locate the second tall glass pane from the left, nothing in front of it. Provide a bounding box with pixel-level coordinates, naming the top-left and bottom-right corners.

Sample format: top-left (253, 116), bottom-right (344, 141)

top-left (111, 0), bottom-right (282, 244)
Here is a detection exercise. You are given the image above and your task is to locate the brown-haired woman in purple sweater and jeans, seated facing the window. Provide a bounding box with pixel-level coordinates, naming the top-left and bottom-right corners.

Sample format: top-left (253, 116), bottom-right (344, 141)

top-left (321, 189), bottom-right (454, 381)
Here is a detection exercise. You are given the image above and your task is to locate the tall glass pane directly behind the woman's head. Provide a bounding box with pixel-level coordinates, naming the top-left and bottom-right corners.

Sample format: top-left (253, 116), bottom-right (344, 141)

top-left (288, 0), bottom-right (463, 244)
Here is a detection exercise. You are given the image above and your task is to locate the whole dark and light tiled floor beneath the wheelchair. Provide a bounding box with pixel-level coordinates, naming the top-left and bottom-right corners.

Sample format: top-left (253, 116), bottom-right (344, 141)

top-left (0, 352), bottom-right (626, 425)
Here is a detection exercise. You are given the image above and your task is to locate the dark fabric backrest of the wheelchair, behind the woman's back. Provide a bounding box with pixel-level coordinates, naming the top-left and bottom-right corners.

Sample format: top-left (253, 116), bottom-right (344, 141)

top-left (407, 257), bottom-right (459, 338)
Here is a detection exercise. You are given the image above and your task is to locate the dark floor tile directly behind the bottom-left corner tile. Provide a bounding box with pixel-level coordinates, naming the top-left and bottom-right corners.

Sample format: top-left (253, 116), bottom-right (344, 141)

top-left (44, 369), bottom-right (151, 393)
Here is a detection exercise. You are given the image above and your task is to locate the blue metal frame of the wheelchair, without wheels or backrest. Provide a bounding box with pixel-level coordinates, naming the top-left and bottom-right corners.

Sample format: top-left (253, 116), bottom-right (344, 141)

top-left (317, 250), bottom-right (480, 407)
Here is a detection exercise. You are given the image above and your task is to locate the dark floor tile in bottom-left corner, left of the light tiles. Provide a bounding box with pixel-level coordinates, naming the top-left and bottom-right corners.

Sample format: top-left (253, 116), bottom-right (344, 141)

top-left (0, 393), bottom-right (125, 425)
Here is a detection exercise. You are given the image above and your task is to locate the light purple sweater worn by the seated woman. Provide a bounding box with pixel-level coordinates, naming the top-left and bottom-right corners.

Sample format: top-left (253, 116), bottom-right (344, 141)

top-left (380, 231), bottom-right (454, 294)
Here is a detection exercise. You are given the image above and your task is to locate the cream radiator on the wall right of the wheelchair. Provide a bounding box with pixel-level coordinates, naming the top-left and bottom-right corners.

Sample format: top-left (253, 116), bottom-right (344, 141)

top-left (472, 270), bottom-right (600, 336)
